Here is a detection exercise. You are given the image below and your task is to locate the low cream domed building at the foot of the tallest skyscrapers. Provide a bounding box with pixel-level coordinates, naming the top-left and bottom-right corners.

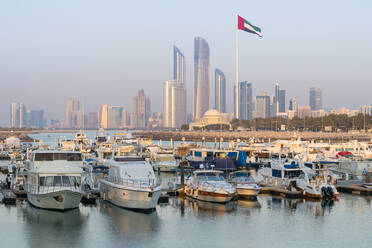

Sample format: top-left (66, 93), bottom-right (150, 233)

top-left (189, 109), bottom-right (232, 131)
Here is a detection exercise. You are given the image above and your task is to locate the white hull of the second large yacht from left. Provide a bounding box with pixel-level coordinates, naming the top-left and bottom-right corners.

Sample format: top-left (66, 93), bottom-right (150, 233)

top-left (100, 181), bottom-right (161, 211)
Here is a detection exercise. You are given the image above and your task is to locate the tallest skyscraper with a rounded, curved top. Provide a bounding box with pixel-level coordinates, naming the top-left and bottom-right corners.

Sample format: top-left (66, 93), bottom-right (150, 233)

top-left (193, 37), bottom-right (210, 119)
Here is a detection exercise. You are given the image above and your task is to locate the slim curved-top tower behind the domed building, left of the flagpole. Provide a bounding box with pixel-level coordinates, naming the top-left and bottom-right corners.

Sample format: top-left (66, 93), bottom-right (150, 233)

top-left (214, 69), bottom-right (226, 113)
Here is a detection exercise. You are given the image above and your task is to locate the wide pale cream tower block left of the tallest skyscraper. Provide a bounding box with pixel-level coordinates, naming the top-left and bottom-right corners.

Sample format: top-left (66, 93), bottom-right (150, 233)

top-left (163, 80), bottom-right (186, 128)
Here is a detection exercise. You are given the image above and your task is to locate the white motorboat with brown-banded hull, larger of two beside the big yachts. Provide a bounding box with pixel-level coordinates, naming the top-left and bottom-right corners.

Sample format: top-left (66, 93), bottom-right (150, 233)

top-left (185, 166), bottom-right (236, 203)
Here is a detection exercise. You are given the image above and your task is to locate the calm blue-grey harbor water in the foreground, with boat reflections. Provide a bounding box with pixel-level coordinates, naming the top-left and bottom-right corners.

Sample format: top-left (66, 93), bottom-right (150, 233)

top-left (0, 194), bottom-right (372, 248)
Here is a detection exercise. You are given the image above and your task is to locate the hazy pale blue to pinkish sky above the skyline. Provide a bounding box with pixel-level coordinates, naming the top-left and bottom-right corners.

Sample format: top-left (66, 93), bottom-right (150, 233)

top-left (0, 0), bottom-right (372, 125)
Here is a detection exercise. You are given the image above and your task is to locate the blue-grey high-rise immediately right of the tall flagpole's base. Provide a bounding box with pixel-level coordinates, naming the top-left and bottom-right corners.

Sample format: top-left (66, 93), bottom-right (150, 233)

top-left (234, 81), bottom-right (253, 120)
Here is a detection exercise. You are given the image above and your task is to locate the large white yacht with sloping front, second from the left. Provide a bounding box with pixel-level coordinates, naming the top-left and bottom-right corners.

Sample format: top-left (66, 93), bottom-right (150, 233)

top-left (100, 156), bottom-right (161, 211)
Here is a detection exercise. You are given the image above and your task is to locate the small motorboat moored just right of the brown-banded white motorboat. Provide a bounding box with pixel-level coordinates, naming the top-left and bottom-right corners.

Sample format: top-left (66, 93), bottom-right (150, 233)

top-left (228, 170), bottom-right (261, 197)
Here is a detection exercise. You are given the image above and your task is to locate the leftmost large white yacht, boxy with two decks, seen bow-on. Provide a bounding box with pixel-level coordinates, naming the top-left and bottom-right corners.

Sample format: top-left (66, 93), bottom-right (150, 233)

top-left (25, 150), bottom-right (83, 211)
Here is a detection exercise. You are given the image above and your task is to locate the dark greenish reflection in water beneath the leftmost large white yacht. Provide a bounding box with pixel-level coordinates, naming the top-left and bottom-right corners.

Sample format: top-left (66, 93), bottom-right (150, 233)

top-left (21, 204), bottom-right (86, 247)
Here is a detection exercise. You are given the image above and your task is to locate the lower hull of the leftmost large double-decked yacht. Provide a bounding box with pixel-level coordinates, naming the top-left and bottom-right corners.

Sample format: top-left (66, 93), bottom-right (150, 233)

top-left (27, 190), bottom-right (82, 211)
